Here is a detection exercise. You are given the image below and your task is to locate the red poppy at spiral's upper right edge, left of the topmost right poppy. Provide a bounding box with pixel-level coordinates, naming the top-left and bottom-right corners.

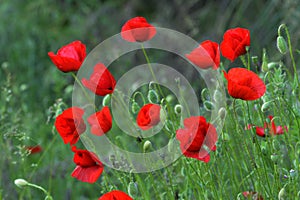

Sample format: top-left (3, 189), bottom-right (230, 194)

top-left (185, 40), bottom-right (220, 69)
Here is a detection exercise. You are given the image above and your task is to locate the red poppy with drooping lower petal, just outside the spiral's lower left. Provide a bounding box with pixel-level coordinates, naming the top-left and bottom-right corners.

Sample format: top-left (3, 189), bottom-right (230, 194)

top-left (72, 146), bottom-right (104, 183)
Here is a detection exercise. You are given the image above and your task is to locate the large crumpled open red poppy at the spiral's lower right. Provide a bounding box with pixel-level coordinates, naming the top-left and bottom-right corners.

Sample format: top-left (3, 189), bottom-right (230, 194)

top-left (176, 116), bottom-right (218, 162)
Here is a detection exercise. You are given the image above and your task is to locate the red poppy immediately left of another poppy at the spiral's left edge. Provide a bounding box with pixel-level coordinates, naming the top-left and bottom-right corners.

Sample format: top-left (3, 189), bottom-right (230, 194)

top-left (54, 107), bottom-right (86, 145)
